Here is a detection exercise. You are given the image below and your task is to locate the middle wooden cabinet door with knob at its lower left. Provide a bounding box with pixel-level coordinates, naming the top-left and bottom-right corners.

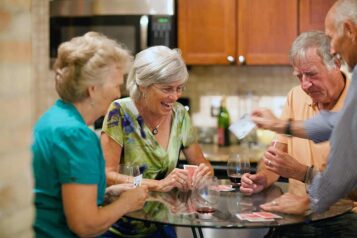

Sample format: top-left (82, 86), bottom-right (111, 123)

top-left (237, 0), bottom-right (298, 65)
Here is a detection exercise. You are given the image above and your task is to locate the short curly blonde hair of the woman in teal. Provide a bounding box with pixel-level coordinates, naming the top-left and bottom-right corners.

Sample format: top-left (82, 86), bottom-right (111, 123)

top-left (54, 32), bottom-right (133, 103)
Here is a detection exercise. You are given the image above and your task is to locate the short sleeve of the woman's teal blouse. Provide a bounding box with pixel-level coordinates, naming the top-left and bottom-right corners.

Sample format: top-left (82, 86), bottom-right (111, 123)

top-left (53, 127), bottom-right (104, 184)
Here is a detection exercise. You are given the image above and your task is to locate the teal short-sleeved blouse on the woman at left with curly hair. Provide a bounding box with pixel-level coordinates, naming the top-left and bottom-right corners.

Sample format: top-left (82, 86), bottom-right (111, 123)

top-left (32, 100), bottom-right (106, 237)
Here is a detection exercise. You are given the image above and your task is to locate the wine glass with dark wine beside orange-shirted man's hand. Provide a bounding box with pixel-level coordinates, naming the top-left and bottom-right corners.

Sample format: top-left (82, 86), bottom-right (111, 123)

top-left (227, 154), bottom-right (250, 188)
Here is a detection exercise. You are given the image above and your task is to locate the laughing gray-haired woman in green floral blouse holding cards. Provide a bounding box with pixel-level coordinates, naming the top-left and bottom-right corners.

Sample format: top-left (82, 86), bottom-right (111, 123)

top-left (101, 46), bottom-right (213, 236)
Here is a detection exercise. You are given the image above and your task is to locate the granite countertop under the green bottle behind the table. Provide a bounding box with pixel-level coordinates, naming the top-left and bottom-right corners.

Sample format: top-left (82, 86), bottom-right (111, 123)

top-left (180, 144), bottom-right (266, 163)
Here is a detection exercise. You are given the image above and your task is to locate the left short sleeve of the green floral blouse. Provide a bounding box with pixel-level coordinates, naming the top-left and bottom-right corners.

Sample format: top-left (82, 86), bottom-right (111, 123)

top-left (102, 101), bottom-right (124, 146)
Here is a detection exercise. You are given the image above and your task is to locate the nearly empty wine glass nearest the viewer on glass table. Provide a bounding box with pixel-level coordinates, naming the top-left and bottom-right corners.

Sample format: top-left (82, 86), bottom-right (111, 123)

top-left (193, 176), bottom-right (219, 219)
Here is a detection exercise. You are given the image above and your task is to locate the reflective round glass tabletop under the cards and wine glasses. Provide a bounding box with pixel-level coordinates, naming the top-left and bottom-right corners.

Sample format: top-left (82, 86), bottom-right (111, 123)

top-left (111, 180), bottom-right (353, 237)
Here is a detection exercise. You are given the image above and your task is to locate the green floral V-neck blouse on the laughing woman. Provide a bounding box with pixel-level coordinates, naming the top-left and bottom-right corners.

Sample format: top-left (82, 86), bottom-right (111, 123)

top-left (103, 98), bottom-right (197, 179)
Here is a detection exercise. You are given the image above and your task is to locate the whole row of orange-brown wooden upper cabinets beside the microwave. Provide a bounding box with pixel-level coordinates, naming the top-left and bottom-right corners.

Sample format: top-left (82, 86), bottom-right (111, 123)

top-left (178, 0), bottom-right (335, 65)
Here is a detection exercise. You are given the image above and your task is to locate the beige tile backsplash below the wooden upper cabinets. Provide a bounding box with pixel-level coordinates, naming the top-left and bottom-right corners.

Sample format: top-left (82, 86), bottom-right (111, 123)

top-left (183, 66), bottom-right (299, 127)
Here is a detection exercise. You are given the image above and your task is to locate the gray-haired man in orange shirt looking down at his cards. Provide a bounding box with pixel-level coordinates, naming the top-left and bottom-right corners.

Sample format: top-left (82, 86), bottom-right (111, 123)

top-left (240, 31), bottom-right (350, 196)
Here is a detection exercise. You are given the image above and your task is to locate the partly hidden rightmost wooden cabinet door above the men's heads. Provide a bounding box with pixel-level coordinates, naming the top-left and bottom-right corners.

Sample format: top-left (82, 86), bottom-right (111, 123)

top-left (299, 0), bottom-right (336, 32)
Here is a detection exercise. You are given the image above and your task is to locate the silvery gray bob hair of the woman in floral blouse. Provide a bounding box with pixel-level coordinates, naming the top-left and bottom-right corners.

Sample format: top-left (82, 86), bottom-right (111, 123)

top-left (126, 46), bottom-right (188, 101)
